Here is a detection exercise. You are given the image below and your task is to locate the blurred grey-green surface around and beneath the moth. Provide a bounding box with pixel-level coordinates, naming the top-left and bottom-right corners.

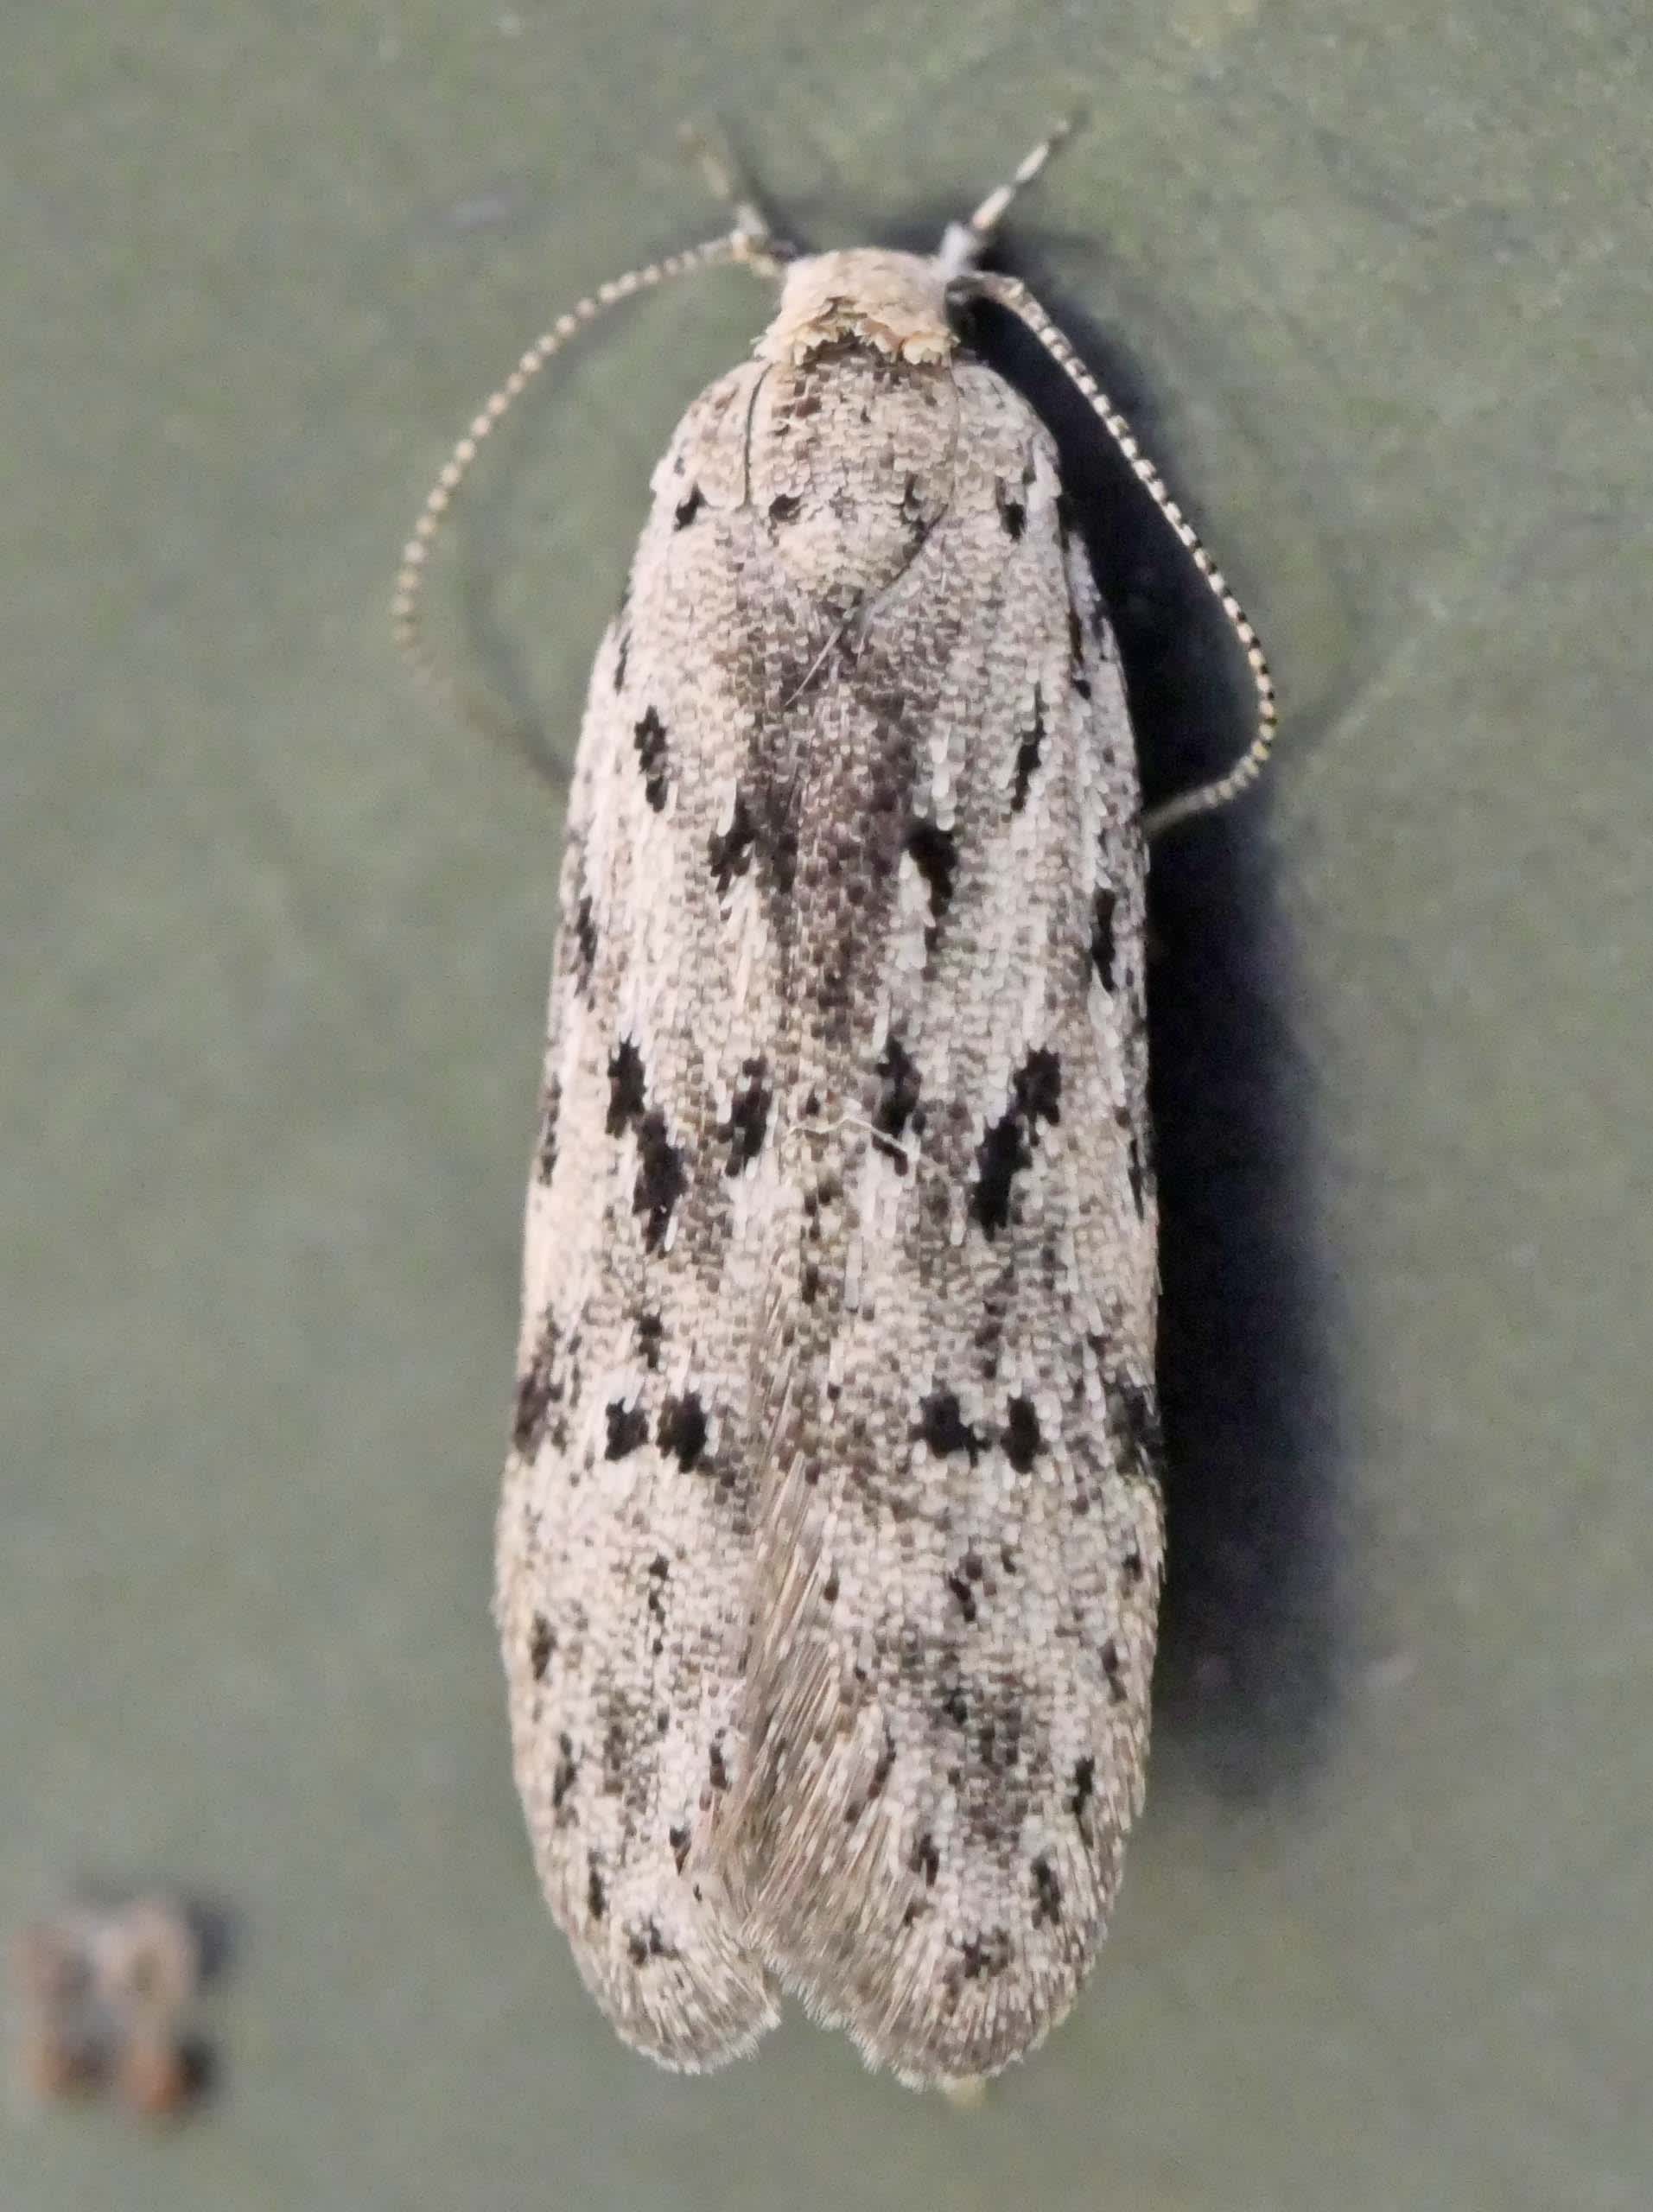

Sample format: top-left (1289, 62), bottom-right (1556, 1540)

top-left (0, 0), bottom-right (1653, 2212)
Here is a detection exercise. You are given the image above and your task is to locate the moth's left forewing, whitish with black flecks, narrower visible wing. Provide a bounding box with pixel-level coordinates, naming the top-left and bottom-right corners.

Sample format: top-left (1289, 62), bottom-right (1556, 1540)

top-left (498, 376), bottom-right (777, 2069)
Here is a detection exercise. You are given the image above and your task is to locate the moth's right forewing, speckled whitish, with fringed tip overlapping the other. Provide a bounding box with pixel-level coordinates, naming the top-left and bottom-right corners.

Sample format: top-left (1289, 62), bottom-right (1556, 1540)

top-left (719, 365), bottom-right (1161, 2082)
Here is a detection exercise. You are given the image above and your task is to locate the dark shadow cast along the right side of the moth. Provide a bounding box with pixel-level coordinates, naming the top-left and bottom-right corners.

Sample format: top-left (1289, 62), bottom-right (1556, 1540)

top-left (974, 289), bottom-right (1341, 1796)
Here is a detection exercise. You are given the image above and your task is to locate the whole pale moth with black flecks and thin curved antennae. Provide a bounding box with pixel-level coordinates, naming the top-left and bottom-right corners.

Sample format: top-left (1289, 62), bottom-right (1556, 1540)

top-left (396, 125), bottom-right (1275, 2086)
